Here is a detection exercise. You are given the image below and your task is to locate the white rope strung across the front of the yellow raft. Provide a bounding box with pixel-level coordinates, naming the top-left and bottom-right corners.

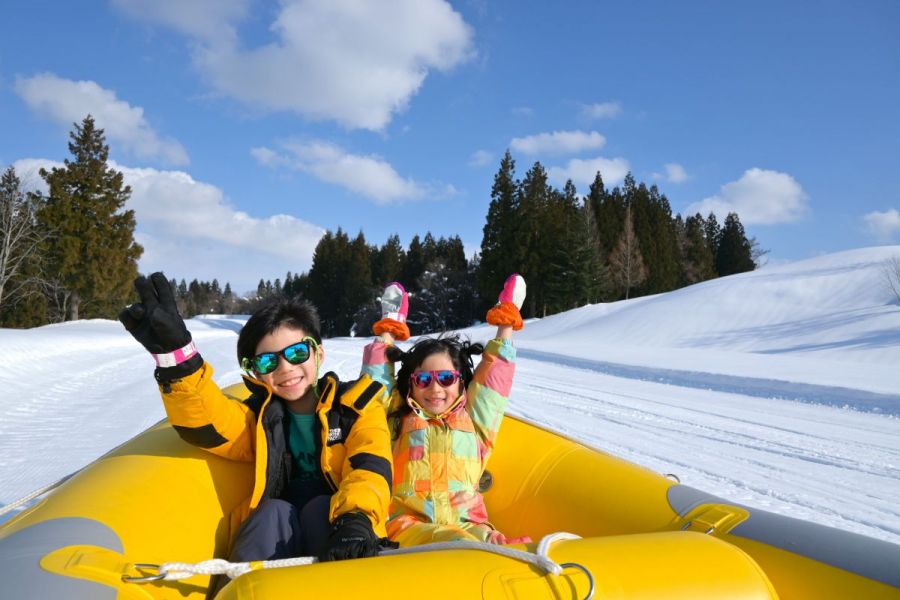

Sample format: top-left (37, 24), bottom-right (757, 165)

top-left (122, 531), bottom-right (594, 600)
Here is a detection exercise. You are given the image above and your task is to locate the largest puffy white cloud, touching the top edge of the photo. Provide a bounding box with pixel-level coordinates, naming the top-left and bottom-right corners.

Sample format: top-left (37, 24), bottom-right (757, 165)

top-left (118, 0), bottom-right (474, 130)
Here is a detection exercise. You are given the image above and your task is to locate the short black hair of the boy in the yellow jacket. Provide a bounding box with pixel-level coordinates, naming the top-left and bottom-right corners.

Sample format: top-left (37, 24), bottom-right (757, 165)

top-left (238, 297), bottom-right (322, 364)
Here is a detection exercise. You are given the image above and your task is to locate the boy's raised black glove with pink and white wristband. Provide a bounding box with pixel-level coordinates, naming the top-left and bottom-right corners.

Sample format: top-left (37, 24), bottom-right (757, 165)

top-left (119, 273), bottom-right (203, 383)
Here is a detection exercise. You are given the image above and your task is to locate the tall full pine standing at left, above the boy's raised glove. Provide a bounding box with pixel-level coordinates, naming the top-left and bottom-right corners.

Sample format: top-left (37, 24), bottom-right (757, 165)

top-left (38, 115), bottom-right (143, 320)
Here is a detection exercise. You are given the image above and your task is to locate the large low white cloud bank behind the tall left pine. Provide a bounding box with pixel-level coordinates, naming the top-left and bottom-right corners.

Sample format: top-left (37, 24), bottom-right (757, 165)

top-left (14, 159), bottom-right (325, 293)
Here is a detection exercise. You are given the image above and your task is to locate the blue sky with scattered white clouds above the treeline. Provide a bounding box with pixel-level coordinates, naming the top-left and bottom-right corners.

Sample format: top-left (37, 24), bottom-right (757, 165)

top-left (0, 0), bottom-right (900, 291)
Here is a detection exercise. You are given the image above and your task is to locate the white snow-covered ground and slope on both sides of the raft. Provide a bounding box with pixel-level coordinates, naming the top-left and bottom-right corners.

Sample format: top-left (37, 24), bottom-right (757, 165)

top-left (0, 247), bottom-right (900, 543)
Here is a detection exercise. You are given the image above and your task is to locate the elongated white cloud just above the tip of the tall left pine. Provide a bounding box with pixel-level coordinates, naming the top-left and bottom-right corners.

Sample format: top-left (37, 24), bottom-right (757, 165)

top-left (15, 73), bottom-right (190, 165)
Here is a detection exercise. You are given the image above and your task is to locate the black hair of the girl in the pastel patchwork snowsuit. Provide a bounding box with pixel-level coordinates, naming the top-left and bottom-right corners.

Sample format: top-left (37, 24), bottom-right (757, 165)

top-left (387, 334), bottom-right (484, 418)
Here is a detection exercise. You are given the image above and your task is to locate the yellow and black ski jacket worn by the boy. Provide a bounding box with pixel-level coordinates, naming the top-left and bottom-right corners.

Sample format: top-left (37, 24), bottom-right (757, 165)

top-left (160, 363), bottom-right (392, 536)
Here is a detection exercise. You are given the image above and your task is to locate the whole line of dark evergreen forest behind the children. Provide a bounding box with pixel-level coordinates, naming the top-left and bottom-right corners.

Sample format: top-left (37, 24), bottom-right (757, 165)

top-left (0, 116), bottom-right (765, 336)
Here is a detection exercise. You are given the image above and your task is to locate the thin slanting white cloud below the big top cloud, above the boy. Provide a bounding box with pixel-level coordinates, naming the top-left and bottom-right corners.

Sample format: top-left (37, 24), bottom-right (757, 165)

top-left (250, 140), bottom-right (426, 204)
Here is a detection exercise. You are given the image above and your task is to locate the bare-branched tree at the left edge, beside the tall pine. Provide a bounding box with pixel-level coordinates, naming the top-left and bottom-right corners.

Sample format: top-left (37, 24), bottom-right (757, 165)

top-left (0, 167), bottom-right (45, 306)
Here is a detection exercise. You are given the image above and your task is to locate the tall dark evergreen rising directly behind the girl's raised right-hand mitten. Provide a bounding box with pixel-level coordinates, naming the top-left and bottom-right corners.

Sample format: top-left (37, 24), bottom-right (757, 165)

top-left (477, 150), bottom-right (524, 310)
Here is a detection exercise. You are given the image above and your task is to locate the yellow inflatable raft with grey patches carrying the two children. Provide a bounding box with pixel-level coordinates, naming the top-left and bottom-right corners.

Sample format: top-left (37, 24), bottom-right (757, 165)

top-left (0, 386), bottom-right (900, 600)
